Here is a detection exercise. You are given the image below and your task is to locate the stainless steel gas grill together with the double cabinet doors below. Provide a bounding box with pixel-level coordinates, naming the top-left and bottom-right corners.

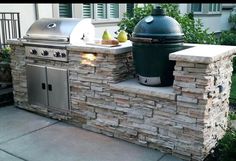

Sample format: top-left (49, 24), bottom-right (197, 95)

top-left (23, 18), bottom-right (95, 112)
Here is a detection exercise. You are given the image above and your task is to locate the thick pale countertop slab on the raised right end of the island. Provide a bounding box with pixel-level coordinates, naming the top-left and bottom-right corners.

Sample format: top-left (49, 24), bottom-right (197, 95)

top-left (169, 44), bottom-right (236, 64)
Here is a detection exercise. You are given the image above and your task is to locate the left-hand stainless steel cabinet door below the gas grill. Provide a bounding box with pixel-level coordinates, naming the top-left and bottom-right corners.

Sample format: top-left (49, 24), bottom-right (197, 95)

top-left (26, 64), bottom-right (48, 106)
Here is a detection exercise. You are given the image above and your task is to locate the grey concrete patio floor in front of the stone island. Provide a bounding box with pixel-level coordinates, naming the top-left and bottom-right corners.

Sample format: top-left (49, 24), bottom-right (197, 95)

top-left (0, 106), bottom-right (182, 161)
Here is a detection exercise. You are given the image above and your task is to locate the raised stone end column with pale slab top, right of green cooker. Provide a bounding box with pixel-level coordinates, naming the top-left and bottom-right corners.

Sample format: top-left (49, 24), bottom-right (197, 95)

top-left (170, 45), bottom-right (236, 160)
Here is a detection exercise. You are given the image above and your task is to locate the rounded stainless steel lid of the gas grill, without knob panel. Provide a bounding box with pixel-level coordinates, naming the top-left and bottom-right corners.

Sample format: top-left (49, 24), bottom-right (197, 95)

top-left (24, 18), bottom-right (95, 44)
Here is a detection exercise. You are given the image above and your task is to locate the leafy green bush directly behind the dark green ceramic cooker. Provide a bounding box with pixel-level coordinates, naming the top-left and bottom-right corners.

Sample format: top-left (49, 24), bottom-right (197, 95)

top-left (118, 3), bottom-right (217, 44)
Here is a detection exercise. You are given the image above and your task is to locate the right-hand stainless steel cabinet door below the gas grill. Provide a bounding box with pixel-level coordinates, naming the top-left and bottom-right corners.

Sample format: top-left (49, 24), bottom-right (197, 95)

top-left (47, 67), bottom-right (69, 110)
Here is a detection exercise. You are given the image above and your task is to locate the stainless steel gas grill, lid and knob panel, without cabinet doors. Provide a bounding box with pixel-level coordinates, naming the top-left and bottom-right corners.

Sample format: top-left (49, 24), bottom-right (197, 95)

top-left (23, 18), bottom-right (95, 61)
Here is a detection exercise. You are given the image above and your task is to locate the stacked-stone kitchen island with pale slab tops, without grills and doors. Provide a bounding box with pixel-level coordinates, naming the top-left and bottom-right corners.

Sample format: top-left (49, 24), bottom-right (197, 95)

top-left (8, 40), bottom-right (236, 160)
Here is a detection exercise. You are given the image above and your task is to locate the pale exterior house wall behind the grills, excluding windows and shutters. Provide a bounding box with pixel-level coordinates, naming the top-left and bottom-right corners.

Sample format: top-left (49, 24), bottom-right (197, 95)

top-left (0, 3), bottom-right (236, 38)
